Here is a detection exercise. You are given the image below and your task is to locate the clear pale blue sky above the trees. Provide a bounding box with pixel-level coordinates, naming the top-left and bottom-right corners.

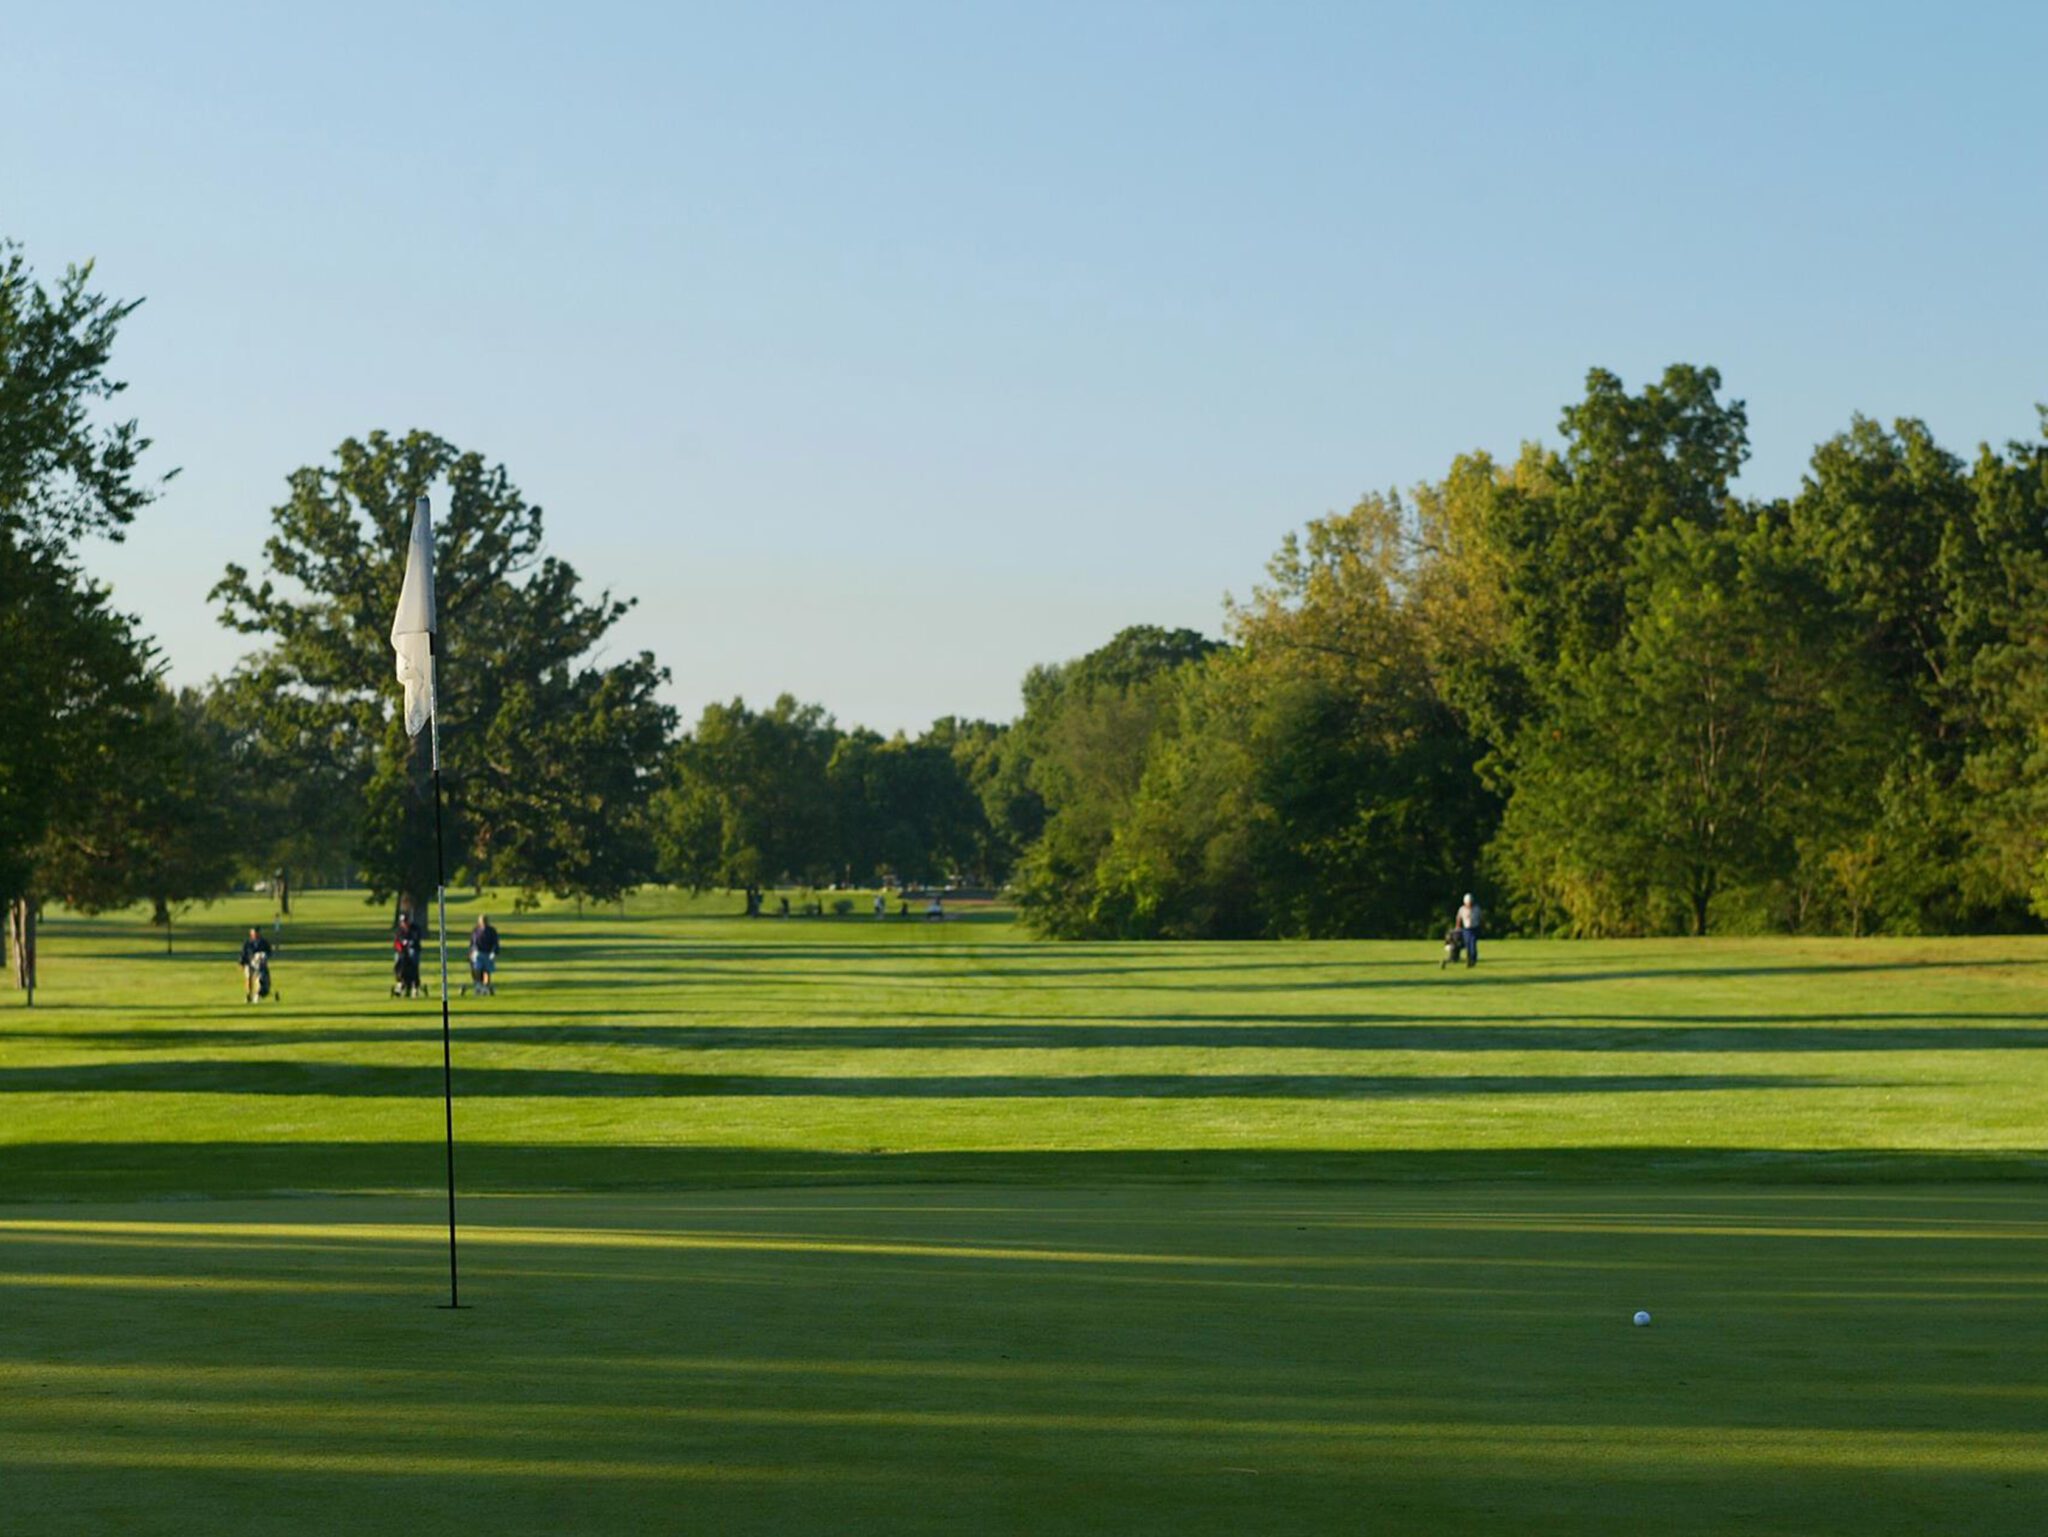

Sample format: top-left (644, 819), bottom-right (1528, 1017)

top-left (0, 0), bottom-right (2048, 730)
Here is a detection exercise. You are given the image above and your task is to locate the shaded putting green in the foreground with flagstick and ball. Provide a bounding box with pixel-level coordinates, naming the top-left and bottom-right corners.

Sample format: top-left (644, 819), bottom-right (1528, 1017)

top-left (0, 1185), bottom-right (2048, 1533)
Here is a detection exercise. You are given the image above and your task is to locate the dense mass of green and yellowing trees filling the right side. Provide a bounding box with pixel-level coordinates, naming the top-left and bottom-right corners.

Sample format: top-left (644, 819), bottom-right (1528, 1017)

top-left (1014, 365), bottom-right (2048, 937)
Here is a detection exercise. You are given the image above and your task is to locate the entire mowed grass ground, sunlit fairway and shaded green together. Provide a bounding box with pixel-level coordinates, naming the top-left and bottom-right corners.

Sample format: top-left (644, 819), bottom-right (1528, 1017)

top-left (0, 896), bottom-right (2048, 1533)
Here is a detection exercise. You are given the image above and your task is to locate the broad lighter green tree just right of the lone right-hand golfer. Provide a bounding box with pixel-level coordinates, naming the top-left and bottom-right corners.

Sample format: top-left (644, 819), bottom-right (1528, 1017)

top-left (1499, 516), bottom-right (1876, 934)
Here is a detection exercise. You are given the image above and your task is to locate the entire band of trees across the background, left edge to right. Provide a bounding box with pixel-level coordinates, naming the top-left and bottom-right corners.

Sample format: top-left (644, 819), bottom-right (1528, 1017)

top-left (0, 246), bottom-right (2048, 1000)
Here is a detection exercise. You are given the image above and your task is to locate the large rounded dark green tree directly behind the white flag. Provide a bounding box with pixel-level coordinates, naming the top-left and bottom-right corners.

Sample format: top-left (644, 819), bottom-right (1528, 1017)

top-left (213, 432), bottom-right (668, 914)
